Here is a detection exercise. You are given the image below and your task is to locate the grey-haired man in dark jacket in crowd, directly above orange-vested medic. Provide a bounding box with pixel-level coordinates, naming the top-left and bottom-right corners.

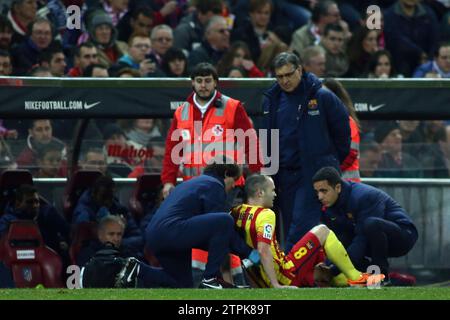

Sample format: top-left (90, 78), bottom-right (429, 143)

top-left (189, 16), bottom-right (230, 67)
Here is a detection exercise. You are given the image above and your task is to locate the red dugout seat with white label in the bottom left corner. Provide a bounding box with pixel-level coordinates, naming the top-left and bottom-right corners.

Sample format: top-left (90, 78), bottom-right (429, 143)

top-left (0, 220), bottom-right (63, 288)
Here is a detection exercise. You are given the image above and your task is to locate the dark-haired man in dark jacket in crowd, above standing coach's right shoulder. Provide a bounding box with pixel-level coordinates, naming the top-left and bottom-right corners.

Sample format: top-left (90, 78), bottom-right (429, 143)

top-left (320, 24), bottom-right (349, 78)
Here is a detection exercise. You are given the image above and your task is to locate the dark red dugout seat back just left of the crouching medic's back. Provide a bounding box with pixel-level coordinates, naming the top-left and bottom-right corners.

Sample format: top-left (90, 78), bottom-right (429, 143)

top-left (129, 174), bottom-right (162, 222)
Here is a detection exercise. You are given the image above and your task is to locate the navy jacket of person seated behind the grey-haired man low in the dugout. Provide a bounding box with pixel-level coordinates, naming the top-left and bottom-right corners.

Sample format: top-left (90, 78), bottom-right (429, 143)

top-left (72, 190), bottom-right (144, 257)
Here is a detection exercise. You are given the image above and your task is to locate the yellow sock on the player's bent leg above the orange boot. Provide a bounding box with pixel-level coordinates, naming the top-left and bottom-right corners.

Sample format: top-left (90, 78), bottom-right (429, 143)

top-left (324, 230), bottom-right (361, 280)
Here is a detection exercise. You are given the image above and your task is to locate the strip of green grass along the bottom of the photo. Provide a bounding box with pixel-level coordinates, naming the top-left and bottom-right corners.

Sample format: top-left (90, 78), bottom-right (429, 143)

top-left (0, 287), bottom-right (450, 301)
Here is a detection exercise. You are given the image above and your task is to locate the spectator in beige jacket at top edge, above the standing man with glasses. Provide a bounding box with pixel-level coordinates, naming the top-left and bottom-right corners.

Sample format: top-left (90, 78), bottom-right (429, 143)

top-left (290, 0), bottom-right (341, 55)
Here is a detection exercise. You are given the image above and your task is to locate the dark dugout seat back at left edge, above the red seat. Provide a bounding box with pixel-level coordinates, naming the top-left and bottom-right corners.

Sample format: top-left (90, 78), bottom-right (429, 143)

top-left (0, 169), bottom-right (33, 215)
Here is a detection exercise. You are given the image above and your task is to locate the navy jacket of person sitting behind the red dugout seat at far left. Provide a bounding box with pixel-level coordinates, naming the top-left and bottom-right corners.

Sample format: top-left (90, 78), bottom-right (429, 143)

top-left (0, 201), bottom-right (69, 252)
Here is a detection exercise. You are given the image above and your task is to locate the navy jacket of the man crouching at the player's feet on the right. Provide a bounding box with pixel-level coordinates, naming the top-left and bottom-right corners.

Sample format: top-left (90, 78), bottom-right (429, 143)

top-left (322, 181), bottom-right (417, 265)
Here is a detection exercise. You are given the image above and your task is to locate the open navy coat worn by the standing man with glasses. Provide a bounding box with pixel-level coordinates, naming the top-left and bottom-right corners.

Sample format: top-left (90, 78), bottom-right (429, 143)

top-left (263, 72), bottom-right (351, 179)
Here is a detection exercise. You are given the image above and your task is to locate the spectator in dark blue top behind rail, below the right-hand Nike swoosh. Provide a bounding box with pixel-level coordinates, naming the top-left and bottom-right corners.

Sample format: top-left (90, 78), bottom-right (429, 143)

top-left (375, 121), bottom-right (423, 178)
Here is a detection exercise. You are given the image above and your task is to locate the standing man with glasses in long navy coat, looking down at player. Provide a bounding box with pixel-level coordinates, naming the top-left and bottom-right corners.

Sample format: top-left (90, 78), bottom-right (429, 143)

top-left (263, 52), bottom-right (350, 252)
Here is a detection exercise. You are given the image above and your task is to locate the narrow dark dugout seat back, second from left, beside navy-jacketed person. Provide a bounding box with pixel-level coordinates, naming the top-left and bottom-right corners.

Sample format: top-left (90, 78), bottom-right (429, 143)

top-left (63, 170), bottom-right (102, 222)
